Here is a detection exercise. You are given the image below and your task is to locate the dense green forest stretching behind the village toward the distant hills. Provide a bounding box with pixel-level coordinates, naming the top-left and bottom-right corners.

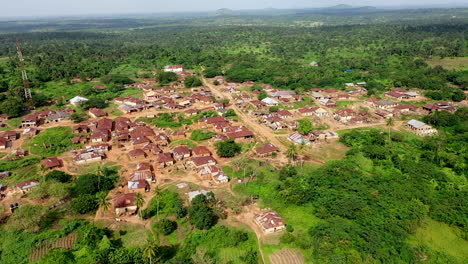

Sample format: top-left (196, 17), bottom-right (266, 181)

top-left (0, 20), bottom-right (468, 115)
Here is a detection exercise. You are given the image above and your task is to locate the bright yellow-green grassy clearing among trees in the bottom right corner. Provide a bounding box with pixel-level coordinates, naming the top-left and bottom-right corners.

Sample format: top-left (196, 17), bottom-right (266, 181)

top-left (409, 219), bottom-right (468, 264)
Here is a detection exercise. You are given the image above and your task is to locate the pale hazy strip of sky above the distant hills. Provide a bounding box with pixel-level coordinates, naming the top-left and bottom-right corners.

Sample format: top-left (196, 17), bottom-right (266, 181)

top-left (0, 0), bottom-right (468, 17)
